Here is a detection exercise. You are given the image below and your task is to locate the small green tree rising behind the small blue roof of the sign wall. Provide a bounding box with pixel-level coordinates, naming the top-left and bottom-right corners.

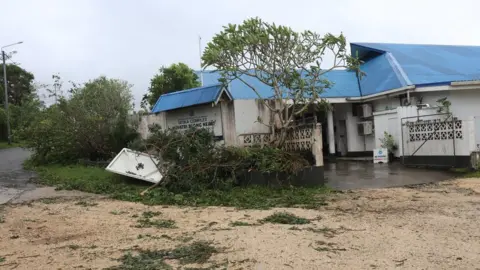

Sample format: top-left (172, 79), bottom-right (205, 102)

top-left (142, 63), bottom-right (200, 108)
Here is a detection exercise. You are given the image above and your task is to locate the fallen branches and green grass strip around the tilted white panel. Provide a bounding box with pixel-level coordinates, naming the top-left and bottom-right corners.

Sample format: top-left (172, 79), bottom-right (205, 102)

top-left (29, 128), bottom-right (329, 208)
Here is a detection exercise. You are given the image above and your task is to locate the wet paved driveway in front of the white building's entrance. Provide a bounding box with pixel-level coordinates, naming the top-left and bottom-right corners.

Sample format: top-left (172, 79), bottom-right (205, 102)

top-left (325, 161), bottom-right (453, 190)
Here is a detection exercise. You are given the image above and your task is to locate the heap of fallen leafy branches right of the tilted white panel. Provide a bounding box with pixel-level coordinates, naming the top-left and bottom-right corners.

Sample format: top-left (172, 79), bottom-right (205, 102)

top-left (132, 127), bottom-right (308, 192)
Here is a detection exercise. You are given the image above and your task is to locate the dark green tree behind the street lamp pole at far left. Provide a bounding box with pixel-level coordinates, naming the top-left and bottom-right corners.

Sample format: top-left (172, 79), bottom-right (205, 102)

top-left (0, 64), bottom-right (35, 105)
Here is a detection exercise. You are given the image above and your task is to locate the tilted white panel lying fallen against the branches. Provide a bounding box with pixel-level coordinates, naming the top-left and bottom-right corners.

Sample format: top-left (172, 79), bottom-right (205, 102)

top-left (106, 148), bottom-right (163, 183)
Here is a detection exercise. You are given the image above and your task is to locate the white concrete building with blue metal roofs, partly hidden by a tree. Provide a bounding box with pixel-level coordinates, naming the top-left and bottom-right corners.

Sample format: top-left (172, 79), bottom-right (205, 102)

top-left (142, 43), bottom-right (480, 167)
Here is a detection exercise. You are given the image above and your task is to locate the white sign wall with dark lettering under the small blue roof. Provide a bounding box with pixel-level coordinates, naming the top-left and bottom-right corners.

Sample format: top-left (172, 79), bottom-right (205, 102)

top-left (166, 104), bottom-right (223, 136)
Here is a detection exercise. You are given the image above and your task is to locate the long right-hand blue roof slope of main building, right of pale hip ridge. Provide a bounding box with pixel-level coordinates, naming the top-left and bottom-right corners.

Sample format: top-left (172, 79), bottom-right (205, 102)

top-left (351, 43), bottom-right (480, 86)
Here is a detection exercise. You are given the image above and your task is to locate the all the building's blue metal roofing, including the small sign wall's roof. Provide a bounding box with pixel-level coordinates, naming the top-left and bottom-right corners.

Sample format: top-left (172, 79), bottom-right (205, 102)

top-left (156, 43), bottom-right (480, 112)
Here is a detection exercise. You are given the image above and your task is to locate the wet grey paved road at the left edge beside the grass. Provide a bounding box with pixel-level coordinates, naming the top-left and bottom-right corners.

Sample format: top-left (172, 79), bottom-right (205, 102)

top-left (0, 148), bottom-right (35, 204)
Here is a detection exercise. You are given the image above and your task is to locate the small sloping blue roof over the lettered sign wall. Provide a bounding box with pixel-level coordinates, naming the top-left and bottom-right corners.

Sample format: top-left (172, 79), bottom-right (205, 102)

top-left (152, 83), bottom-right (230, 113)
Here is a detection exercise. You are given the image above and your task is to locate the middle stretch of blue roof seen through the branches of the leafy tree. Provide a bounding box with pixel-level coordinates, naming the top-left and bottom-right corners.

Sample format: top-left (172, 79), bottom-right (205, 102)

top-left (199, 70), bottom-right (360, 99)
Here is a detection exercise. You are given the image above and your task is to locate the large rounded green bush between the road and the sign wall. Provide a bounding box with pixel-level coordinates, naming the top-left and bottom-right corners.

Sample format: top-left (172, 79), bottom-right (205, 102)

top-left (22, 77), bottom-right (137, 164)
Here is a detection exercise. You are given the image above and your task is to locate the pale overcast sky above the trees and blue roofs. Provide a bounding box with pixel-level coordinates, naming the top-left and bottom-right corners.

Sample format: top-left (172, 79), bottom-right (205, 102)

top-left (0, 0), bottom-right (480, 106)
